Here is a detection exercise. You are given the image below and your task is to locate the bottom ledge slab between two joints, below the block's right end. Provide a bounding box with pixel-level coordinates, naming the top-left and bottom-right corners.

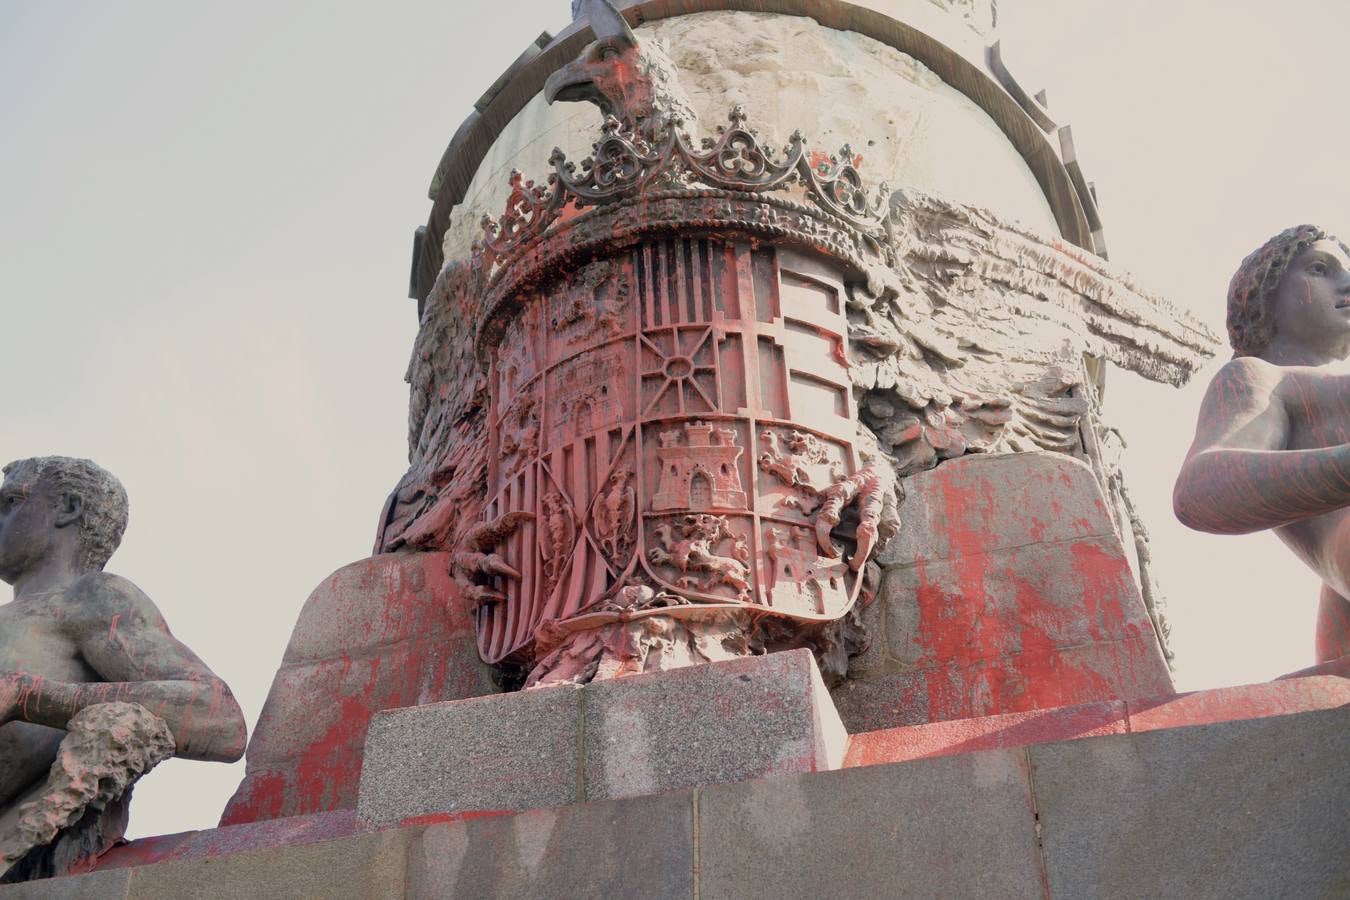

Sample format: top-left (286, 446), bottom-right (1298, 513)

top-left (698, 750), bottom-right (1042, 900)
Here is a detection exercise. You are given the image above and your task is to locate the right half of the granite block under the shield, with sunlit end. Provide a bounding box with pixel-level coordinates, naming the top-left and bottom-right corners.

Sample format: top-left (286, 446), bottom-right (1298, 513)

top-left (583, 650), bottom-right (848, 800)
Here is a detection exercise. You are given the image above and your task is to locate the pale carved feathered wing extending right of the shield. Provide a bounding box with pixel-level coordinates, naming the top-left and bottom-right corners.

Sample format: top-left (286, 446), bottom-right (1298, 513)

top-left (849, 190), bottom-right (1219, 472)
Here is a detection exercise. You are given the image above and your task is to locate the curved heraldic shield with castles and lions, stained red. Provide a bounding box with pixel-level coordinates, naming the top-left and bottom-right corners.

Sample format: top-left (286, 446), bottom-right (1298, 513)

top-left (478, 237), bottom-right (860, 663)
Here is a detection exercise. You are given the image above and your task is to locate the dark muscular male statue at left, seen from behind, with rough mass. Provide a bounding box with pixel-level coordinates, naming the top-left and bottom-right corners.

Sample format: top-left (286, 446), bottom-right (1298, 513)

top-left (0, 456), bottom-right (246, 881)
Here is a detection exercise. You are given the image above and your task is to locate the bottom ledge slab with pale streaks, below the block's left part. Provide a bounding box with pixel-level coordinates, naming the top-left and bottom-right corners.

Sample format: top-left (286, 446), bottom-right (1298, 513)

top-left (408, 792), bottom-right (694, 900)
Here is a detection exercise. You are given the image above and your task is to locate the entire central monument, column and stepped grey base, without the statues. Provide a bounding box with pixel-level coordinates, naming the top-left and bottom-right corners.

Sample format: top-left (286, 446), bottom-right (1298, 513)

top-left (13, 0), bottom-right (1350, 900)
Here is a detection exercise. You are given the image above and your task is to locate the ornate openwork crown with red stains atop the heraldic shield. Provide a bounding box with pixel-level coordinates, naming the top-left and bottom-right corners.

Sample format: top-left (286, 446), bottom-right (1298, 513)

top-left (474, 107), bottom-right (896, 367)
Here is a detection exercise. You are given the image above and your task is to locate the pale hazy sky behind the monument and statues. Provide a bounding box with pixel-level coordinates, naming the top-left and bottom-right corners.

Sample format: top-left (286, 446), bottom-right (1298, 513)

top-left (0, 0), bottom-right (1350, 835)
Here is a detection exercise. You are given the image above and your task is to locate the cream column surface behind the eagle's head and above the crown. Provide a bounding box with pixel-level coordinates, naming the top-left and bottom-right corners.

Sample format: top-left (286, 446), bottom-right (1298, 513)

top-left (443, 12), bottom-right (1056, 260)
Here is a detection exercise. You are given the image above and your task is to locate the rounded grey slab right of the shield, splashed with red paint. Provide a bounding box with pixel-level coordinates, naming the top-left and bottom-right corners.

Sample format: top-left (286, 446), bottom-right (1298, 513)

top-left (834, 453), bottom-right (1172, 731)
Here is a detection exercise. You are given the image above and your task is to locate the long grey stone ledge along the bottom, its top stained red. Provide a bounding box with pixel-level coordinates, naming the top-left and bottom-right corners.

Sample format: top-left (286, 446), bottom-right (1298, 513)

top-left (0, 674), bottom-right (1350, 900)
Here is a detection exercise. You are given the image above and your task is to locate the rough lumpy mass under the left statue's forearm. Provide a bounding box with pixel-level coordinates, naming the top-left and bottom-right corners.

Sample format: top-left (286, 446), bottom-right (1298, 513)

top-left (0, 703), bottom-right (174, 881)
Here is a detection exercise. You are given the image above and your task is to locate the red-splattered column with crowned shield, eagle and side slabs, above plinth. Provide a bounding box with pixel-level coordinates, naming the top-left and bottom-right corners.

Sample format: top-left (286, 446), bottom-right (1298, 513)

top-left (224, 0), bottom-right (1216, 823)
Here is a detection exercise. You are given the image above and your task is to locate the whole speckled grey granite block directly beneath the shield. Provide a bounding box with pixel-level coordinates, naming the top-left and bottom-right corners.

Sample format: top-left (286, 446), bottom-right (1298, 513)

top-left (356, 650), bottom-right (848, 824)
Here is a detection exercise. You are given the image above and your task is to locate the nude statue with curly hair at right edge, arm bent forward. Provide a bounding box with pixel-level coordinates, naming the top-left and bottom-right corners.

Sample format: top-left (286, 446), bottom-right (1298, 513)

top-left (1173, 225), bottom-right (1350, 663)
